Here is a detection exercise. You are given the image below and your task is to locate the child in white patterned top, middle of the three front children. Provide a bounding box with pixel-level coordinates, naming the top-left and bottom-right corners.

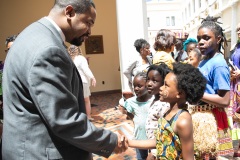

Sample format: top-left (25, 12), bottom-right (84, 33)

top-left (146, 63), bottom-right (171, 158)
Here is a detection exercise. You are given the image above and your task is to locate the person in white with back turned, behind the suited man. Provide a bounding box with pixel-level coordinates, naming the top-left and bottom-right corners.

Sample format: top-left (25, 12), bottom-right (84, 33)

top-left (68, 45), bottom-right (96, 121)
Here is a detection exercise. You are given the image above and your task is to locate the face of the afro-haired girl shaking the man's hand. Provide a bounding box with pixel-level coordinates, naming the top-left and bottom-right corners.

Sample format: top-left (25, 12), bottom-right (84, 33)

top-left (159, 72), bottom-right (179, 103)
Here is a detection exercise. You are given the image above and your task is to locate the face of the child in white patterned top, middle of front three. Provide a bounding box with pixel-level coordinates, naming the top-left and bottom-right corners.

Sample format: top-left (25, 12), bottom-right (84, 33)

top-left (146, 70), bottom-right (163, 95)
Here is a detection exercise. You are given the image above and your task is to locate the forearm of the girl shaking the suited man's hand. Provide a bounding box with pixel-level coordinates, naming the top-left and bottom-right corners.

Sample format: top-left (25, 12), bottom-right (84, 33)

top-left (128, 139), bottom-right (156, 149)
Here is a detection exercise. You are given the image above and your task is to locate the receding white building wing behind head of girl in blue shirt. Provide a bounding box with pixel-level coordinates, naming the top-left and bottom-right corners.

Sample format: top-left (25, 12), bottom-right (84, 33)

top-left (182, 0), bottom-right (240, 56)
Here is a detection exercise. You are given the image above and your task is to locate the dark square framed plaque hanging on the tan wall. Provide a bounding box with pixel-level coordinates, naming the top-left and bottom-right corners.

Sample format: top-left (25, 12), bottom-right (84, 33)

top-left (85, 35), bottom-right (104, 54)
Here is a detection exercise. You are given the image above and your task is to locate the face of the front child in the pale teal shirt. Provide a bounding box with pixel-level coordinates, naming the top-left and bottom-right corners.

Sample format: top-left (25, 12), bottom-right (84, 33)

top-left (133, 76), bottom-right (148, 97)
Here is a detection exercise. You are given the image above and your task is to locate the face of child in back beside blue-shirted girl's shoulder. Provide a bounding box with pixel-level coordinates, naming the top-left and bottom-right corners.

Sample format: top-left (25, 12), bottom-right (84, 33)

top-left (187, 48), bottom-right (202, 68)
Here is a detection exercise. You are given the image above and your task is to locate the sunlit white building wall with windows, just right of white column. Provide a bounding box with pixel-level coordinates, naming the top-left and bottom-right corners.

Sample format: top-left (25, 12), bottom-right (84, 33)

top-left (147, 0), bottom-right (184, 49)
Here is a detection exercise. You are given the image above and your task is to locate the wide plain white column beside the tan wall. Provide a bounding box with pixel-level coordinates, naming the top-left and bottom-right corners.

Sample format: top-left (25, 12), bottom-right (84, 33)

top-left (116, 0), bottom-right (148, 90)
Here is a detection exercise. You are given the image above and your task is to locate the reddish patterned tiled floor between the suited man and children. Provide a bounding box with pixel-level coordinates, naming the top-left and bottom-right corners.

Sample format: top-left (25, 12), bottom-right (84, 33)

top-left (91, 93), bottom-right (136, 160)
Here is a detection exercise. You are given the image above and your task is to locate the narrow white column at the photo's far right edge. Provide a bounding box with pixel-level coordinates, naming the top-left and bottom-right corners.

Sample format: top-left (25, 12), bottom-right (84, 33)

top-left (231, 2), bottom-right (239, 45)
